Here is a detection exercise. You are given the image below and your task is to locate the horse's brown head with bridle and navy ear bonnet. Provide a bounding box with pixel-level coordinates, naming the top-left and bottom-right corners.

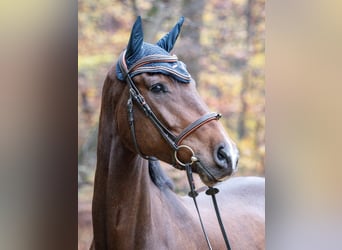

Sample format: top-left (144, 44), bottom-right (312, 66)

top-left (115, 17), bottom-right (238, 186)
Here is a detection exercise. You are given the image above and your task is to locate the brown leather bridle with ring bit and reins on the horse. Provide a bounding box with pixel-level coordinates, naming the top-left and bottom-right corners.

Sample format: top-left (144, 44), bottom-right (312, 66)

top-left (119, 50), bottom-right (231, 250)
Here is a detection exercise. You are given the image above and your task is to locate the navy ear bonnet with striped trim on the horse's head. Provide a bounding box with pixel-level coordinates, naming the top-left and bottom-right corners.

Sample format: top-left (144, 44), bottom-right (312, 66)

top-left (116, 16), bottom-right (191, 83)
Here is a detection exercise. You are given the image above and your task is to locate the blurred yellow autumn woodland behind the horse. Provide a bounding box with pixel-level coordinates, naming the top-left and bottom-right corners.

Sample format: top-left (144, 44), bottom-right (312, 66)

top-left (78, 0), bottom-right (265, 249)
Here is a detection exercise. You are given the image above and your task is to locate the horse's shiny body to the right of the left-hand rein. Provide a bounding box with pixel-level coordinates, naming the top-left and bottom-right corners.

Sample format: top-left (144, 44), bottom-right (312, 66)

top-left (191, 177), bottom-right (265, 249)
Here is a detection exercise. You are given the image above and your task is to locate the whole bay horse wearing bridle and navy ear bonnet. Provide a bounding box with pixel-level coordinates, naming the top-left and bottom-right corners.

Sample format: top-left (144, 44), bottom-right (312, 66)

top-left (91, 17), bottom-right (265, 250)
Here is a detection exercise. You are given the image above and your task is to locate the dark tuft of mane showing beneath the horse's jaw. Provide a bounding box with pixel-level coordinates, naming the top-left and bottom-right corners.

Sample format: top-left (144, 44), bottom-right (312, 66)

top-left (148, 160), bottom-right (174, 190)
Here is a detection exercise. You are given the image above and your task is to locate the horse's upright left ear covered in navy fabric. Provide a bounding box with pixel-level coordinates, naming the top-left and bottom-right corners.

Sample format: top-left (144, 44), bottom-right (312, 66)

top-left (125, 16), bottom-right (144, 61)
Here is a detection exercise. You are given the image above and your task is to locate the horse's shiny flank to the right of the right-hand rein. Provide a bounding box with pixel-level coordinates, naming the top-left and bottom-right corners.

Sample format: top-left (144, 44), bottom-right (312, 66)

top-left (217, 177), bottom-right (265, 249)
